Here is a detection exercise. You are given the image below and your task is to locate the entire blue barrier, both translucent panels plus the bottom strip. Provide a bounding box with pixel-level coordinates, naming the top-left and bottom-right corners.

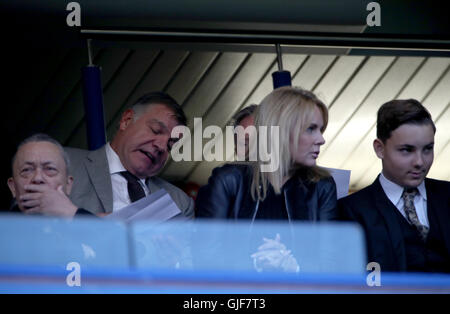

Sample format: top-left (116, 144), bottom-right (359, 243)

top-left (0, 215), bottom-right (450, 294)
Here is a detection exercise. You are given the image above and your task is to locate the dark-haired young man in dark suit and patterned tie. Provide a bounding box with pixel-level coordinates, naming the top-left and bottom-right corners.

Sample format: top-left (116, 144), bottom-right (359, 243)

top-left (338, 99), bottom-right (450, 272)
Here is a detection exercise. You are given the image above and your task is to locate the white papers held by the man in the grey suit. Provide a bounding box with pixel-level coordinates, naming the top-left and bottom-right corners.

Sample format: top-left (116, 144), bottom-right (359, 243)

top-left (106, 189), bottom-right (181, 222)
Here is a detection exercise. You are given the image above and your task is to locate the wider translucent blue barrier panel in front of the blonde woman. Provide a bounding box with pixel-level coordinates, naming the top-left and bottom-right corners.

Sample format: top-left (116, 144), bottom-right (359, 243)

top-left (131, 220), bottom-right (367, 274)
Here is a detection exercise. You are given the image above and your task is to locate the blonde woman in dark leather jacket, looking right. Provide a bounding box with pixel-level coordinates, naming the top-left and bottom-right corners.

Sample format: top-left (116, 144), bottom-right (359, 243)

top-left (196, 87), bottom-right (337, 221)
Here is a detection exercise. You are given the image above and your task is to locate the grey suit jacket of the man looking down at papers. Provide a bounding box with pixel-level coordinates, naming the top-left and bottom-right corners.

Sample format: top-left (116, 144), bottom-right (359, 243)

top-left (65, 146), bottom-right (194, 218)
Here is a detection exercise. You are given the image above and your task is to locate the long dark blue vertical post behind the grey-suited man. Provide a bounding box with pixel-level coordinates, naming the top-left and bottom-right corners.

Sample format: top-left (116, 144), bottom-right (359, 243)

top-left (82, 65), bottom-right (106, 150)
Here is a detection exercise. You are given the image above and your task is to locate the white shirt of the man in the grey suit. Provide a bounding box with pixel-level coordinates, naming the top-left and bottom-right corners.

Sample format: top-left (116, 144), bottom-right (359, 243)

top-left (106, 142), bottom-right (150, 212)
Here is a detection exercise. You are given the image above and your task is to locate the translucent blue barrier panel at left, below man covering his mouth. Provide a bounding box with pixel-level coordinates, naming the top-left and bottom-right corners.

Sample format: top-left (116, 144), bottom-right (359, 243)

top-left (0, 214), bottom-right (129, 268)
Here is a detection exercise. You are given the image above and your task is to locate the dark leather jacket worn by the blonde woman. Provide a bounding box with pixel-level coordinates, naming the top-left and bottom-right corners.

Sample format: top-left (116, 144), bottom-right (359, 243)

top-left (196, 164), bottom-right (337, 221)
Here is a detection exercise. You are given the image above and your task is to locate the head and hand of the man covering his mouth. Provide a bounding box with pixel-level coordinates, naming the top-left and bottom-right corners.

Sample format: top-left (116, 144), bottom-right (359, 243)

top-left (7, 133), bottom-right (86, 217)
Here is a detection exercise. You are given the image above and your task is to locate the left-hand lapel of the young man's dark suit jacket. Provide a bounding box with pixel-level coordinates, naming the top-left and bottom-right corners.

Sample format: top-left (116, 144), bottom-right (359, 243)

top-left (371, 177), bottom-right (406, 269)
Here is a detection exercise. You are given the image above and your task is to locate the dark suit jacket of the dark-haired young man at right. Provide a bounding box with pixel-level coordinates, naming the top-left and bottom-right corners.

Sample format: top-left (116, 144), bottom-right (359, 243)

top-left (338, 178), bottom-right (450, 271)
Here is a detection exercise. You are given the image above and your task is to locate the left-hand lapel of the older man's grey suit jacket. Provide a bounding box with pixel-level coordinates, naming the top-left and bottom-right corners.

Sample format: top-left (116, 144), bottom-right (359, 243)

top-left (85, 146), bottom-right (113, 213)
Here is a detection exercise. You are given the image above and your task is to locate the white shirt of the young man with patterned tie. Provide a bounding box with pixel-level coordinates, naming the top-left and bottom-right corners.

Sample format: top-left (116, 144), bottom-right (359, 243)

top-left (380, 173), bottom-right (430, 227)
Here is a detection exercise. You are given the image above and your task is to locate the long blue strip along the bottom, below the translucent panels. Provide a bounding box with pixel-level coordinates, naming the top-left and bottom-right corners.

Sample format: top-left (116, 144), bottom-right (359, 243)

top-left (0, 265), bottom-right (450, 294)
